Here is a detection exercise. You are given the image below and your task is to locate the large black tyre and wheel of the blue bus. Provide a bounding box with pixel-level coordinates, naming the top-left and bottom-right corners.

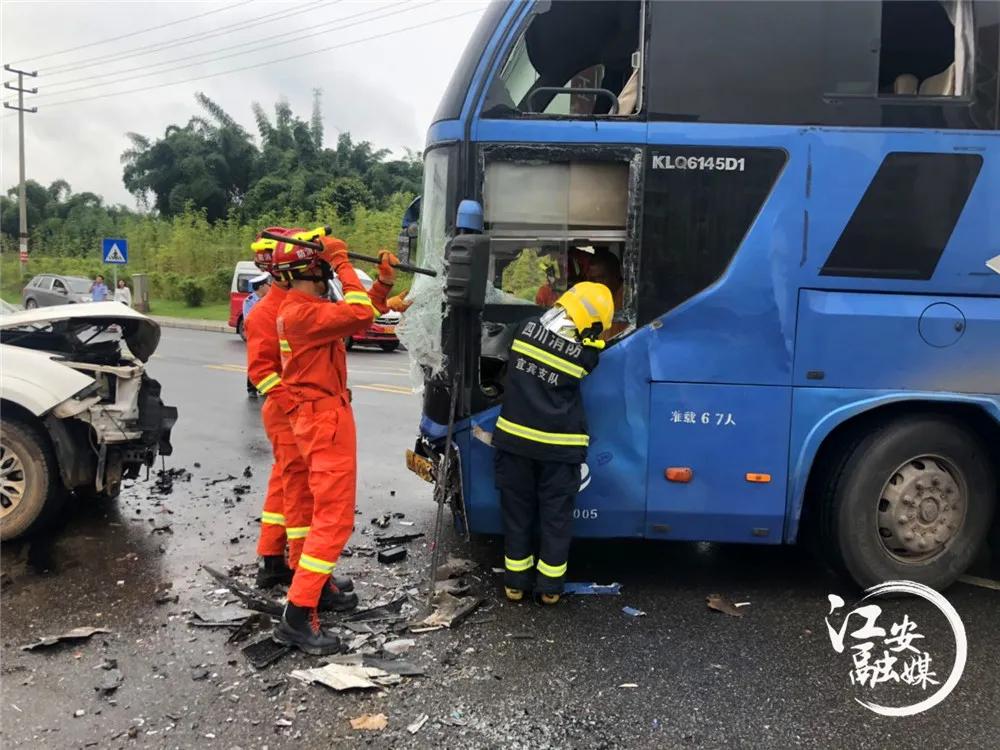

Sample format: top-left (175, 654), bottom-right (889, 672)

top-left (822, 416), bottom-right (997, 589)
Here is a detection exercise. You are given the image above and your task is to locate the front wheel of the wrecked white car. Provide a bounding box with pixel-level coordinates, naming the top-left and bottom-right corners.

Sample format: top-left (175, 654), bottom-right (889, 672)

top-left (0, 417), bottom-right (65, 541)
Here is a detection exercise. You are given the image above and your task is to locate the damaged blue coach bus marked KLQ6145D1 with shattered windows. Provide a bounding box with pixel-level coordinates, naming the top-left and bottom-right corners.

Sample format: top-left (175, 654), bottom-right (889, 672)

top-left (401, 0), bottom-right (1000, 588)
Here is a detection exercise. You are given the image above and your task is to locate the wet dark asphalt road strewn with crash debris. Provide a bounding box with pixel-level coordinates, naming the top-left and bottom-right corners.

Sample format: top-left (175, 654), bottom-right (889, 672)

top-left (0, 330), bottom-right (1000, 749)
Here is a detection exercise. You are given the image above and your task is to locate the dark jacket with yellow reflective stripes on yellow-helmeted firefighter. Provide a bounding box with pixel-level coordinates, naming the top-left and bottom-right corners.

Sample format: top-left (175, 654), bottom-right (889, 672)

top-left (493, 317), bottom-right (600, 463)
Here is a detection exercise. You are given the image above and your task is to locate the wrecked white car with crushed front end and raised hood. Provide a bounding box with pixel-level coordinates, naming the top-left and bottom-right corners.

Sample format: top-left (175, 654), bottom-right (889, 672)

top-left (0, 302), bottom-right (177, 540)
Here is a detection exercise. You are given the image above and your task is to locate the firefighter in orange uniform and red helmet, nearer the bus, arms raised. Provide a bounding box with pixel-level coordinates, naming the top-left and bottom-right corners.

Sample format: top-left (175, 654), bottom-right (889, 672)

top-left (273, 237), bottom-right (398, 656)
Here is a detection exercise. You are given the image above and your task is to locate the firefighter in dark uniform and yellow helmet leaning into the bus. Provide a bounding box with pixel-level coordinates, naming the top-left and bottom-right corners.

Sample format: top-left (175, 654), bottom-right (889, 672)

top-left (493, 282), bottom-right (615, 604)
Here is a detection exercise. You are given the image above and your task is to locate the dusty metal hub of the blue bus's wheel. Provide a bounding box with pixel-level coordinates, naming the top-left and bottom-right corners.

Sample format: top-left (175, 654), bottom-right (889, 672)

top-left (877, 456), bottom-right (966, 562)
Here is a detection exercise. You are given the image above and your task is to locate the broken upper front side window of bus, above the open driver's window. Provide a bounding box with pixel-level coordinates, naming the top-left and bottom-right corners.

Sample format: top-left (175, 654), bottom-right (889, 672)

top-left (483, 0), bottom-right (641, 117)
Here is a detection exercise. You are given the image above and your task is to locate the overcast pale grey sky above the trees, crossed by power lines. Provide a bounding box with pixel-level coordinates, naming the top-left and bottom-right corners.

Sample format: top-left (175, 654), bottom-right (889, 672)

top-left (0, 0), bottom-right (486, 206)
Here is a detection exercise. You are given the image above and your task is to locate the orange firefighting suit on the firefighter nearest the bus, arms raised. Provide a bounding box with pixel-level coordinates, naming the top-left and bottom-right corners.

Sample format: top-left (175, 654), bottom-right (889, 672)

top-left (282, 263), bottom-right (390, 607)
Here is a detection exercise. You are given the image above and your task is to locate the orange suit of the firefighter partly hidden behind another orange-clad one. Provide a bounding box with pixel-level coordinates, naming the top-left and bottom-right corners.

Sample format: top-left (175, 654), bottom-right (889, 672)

top-left (244, 284), bottom-right (313, 568)
